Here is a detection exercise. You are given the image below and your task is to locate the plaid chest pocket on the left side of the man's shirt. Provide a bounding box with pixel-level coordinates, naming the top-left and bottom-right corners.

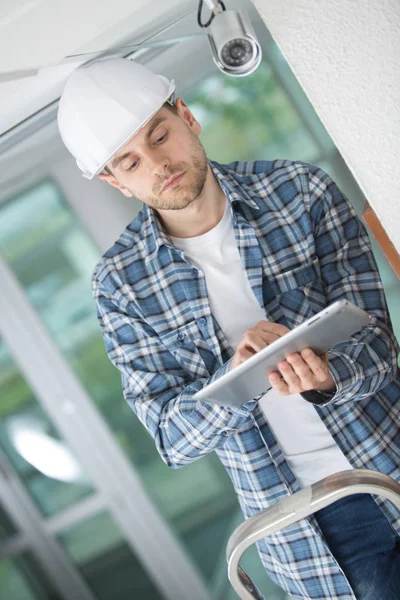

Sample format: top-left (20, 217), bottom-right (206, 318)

top-left (160, 321), bottom-right (210, 381)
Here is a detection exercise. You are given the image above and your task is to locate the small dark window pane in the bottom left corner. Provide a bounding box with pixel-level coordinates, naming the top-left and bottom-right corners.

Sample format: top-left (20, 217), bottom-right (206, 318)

top-left (0, 554), bottom-right (60, 600)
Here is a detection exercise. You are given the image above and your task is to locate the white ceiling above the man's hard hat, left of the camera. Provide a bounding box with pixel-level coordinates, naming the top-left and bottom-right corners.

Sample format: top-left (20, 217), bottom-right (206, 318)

top-left (0, 0), bottom-right (259, 137)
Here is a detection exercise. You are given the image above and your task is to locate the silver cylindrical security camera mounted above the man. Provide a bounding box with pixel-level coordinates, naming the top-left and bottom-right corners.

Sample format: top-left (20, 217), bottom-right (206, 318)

top-left (207, 10), bottom-right (261, 77)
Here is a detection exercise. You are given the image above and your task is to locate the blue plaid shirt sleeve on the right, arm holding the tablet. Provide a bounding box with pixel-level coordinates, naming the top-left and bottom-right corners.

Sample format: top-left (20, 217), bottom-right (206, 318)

top-left (302, 165), bottom-right (399, 404)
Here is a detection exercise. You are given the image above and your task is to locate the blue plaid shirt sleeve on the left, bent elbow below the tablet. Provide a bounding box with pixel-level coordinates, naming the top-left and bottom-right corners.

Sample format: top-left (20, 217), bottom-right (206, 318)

top-left (92, 277), bottom-right (256, 468)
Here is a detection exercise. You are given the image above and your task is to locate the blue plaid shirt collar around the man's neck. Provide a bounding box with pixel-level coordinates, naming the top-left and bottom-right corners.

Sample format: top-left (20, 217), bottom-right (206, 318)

top-left (143, 160), bottom-right (259, 262)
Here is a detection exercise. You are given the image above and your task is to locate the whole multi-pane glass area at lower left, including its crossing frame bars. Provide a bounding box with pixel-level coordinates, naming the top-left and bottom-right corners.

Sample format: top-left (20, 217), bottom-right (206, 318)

top-left (0, 339), bottom-right (165, 600)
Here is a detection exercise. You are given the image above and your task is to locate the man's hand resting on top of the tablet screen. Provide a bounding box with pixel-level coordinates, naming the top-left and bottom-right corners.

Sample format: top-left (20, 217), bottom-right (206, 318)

top-left (231, 321), bottom-right (290, 369)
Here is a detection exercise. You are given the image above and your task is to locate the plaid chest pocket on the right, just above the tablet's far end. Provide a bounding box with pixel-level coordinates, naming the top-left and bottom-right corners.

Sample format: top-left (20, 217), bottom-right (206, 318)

top-left (266, 259), bottom-right (326, 329)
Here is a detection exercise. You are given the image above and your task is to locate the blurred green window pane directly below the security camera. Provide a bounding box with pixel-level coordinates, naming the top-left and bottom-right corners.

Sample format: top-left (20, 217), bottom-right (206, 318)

top-left (185, 62), bottom-right (318, 163)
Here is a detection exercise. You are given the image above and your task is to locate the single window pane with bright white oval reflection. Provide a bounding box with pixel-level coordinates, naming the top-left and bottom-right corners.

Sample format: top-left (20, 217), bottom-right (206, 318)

top-left (0, 339), bottom-right (93, 516)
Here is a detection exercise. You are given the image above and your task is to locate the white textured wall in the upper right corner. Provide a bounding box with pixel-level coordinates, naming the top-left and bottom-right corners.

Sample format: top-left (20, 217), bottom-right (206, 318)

top-left (253, 0), bottom-right (400, 251)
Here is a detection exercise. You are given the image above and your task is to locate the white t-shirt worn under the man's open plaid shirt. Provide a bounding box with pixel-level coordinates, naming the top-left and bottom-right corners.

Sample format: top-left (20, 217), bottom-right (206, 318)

top-left (171, 202), bottom-right (352, 487)
